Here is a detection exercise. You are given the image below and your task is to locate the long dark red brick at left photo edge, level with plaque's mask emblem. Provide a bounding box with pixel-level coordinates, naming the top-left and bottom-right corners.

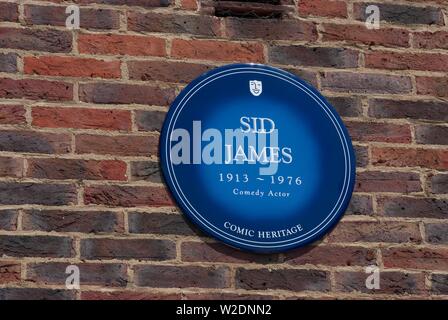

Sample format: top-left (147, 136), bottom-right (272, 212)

top-left (0, 78), bottom-right (73, 101)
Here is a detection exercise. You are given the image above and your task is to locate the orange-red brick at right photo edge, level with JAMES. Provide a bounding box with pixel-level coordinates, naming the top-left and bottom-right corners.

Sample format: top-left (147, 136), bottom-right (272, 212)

top-left (372, 147), bottom-right (448, 170)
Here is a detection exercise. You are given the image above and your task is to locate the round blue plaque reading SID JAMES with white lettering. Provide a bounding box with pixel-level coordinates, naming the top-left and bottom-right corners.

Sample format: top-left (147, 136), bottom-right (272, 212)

top-left (160, 64), bottom-right (355, 252)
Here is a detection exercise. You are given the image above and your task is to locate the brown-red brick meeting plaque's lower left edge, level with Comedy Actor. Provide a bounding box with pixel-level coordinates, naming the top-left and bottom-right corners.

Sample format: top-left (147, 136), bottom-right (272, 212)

top-left (84, 185), bottom-right (173, 207)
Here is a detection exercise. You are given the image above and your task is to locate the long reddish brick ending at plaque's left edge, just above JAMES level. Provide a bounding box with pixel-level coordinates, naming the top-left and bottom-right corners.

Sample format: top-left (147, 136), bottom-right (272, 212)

top-left (76, 134), bottom-right (159, 157)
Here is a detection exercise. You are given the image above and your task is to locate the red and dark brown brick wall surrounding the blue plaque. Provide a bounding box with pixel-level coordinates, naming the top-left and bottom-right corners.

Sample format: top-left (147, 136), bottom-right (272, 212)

top-left (0, 0), bottom-right (448, 299)
